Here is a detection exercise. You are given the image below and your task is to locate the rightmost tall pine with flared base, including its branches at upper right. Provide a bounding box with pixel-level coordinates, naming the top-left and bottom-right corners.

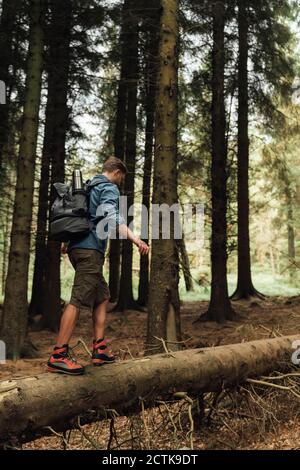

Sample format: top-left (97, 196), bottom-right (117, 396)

top-left (232, 0), bottom-right (294, 300)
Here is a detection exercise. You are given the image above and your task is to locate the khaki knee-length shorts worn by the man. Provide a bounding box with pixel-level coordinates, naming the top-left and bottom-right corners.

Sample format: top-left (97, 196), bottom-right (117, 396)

top-left (68, 248), bottom-right (110, 310)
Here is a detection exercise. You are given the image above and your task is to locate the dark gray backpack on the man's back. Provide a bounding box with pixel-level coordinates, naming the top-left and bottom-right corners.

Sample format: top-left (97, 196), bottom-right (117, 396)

top-left (49, 176), bottom-right (101, 242)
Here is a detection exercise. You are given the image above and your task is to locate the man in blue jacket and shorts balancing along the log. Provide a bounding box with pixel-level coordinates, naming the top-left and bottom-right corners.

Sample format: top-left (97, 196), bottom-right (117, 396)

top-left (47, 157), bottom-right (149, 375)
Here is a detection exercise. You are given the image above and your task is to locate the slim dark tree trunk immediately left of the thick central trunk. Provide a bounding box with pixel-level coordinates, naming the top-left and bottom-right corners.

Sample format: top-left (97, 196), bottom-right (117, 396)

top-left (138, 1), bottom-right (159, 307)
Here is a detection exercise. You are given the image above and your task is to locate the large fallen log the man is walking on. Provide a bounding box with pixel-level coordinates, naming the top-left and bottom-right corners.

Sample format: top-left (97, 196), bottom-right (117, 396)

top-left (0, 335), bottom-right (300, 444)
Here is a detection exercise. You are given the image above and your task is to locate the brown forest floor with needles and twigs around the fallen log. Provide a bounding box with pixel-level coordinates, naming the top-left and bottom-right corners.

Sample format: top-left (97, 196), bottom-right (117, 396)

top-left (0, 297), bottom-right (300, 449)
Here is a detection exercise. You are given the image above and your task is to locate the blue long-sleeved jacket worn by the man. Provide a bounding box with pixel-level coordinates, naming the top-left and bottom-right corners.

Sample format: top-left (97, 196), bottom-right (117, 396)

top-left (67, 175), bottom-right (125, 253)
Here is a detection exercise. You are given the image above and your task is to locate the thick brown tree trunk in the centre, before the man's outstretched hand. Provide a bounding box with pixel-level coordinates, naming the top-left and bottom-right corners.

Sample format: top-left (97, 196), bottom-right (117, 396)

top-left (146, 0), bottom-right (181, 354)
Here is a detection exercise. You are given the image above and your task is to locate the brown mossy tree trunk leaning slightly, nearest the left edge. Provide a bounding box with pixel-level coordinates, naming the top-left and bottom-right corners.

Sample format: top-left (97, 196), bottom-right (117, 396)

top-left (1, 0), bottom-right (43, 359)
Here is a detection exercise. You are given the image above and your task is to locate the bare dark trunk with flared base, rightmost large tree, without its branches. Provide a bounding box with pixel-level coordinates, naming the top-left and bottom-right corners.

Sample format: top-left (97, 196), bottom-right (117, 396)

top-left (231, 0), bottom-right (260, 300)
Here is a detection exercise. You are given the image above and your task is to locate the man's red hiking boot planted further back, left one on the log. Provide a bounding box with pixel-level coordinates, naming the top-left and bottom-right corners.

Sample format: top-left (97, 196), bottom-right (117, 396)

top-left (47, 344), bottom-right (84, 375)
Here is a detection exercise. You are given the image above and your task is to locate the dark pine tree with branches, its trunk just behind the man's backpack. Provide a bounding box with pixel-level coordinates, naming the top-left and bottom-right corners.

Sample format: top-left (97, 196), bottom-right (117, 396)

top-left (29, 0), bottom-right (103, 330)
